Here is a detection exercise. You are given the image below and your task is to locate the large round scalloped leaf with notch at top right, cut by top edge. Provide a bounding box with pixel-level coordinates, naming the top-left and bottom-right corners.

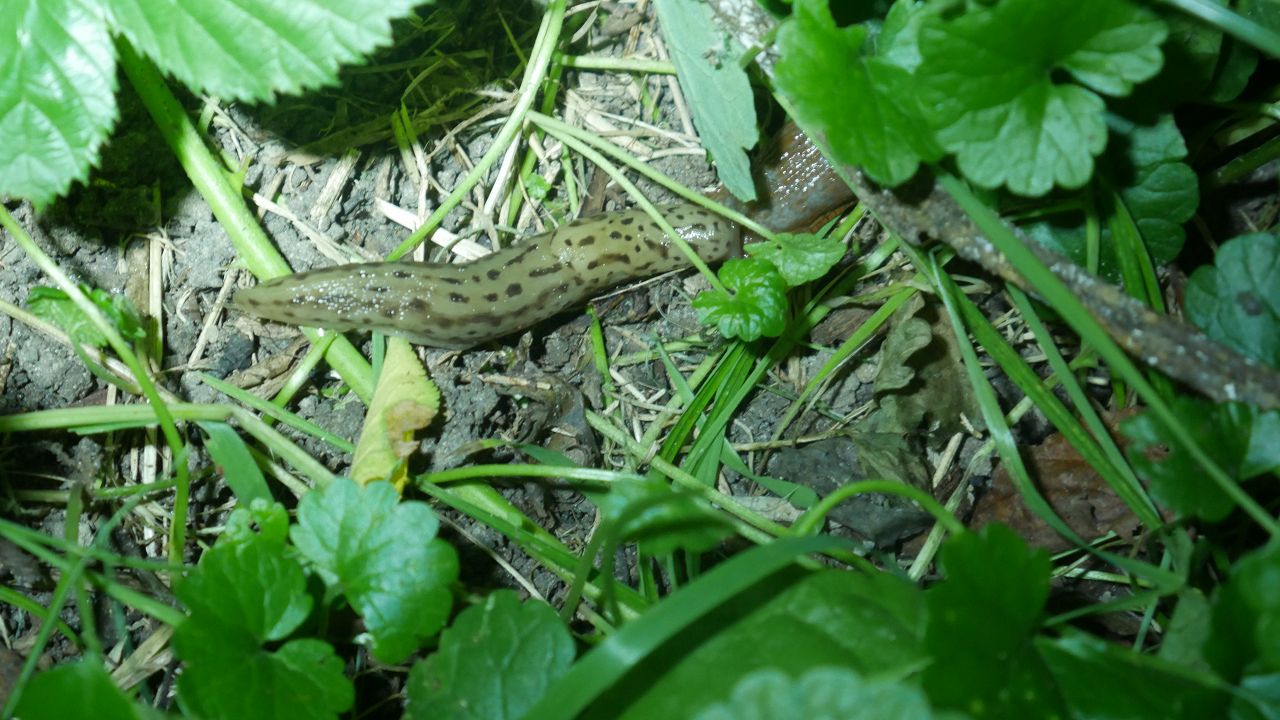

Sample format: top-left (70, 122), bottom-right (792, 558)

top-left (915, 0), bottom-right (1167, 196)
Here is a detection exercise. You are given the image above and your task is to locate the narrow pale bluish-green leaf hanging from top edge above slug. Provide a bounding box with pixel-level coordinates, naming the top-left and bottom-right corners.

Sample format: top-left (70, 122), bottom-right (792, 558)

top-left (654, 0), bottom-right (759, 202)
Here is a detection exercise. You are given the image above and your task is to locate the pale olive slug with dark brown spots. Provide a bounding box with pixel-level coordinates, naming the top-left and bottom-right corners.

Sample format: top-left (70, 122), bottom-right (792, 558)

top-left (234, 205), bottom-right (741, 348)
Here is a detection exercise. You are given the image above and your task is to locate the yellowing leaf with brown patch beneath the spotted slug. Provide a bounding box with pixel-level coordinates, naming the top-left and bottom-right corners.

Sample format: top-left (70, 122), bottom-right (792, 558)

top-left (351, 337), bottom-right (440, 491)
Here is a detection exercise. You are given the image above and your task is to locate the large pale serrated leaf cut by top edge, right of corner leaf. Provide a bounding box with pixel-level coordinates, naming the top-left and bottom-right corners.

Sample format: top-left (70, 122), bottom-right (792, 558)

top-left (101, 0), bottom-right (422, 100)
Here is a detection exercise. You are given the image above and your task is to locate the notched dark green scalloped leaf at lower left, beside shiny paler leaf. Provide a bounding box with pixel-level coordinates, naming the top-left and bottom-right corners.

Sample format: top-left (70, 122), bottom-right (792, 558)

top-left (173, 534), bottom-right (355, 719)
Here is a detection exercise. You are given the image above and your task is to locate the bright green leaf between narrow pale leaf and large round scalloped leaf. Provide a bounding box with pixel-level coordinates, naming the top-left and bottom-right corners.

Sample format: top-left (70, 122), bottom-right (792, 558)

top-left (774, 0), bottom-right (942, 184)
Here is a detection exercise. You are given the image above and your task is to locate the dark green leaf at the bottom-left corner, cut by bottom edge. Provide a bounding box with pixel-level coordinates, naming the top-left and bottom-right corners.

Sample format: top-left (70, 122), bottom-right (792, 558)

top-left (14, 660), bottom-right (146, 720)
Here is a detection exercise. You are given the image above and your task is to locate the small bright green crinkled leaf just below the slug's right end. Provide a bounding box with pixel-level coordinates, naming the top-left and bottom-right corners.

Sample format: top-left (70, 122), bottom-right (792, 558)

top-left (694, 259), bottom-right (787, 341)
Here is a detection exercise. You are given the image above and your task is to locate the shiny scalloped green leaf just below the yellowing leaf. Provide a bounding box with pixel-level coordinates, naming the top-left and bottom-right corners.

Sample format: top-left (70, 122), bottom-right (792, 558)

top-left (289, 478), bottom-right (458, 664)
